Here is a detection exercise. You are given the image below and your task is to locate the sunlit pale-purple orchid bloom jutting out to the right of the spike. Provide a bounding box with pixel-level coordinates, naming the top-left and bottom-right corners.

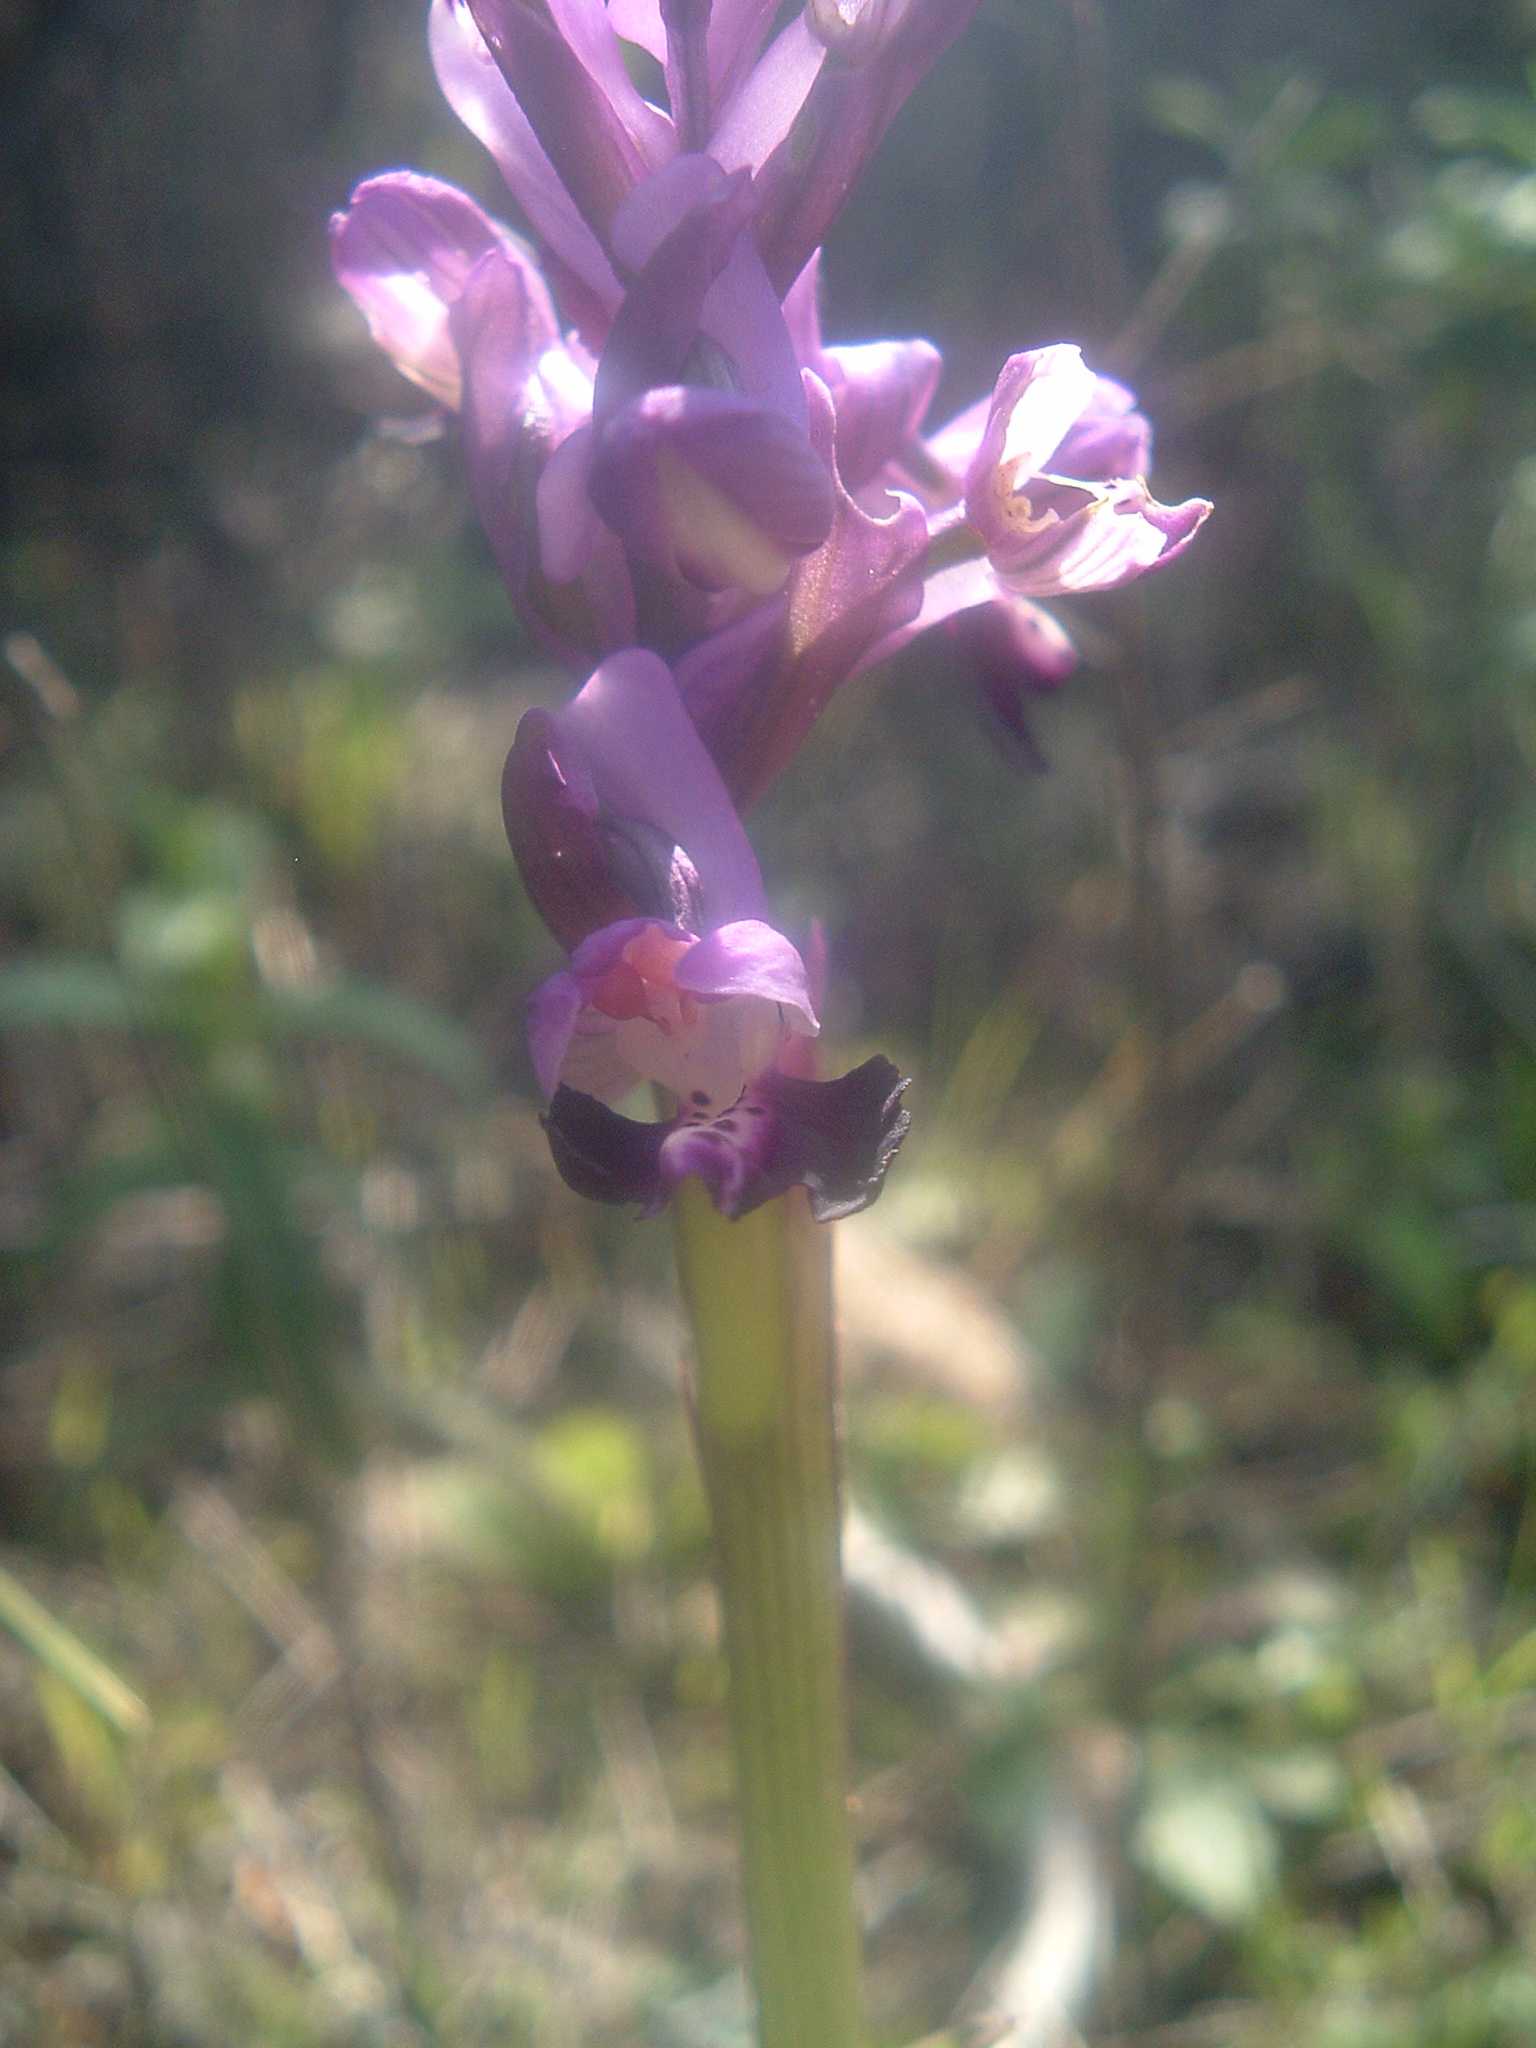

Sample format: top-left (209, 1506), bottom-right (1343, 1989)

top-left (663, 307), bottom-right (1210, 807)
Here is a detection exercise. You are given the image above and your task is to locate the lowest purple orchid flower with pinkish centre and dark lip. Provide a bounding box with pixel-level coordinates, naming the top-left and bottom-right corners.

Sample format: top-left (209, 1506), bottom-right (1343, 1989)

top-left (504, 649), bottom-right (907, 1221)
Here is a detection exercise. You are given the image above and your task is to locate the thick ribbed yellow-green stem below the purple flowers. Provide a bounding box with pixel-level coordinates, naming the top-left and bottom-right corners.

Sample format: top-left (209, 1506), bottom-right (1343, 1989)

top-left (676, 1180), bottom-right (864, 2048)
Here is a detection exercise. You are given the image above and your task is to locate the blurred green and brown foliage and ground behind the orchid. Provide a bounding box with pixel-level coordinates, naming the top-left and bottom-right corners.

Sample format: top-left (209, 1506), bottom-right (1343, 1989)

top-left (0, 0), bottom-right (1536, 2048)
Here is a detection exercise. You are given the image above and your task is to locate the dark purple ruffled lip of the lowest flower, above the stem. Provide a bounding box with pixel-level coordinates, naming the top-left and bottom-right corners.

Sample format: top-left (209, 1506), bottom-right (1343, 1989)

top-left (545, 1053), bottom-right (911, 1223)
